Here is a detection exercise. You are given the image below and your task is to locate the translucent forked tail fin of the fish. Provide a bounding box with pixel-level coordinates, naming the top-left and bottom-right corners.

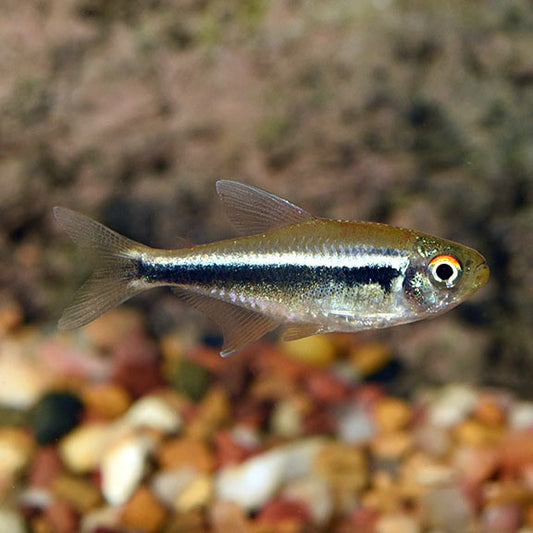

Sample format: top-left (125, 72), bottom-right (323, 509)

top-left (54, 207), bottom-right (150, 329)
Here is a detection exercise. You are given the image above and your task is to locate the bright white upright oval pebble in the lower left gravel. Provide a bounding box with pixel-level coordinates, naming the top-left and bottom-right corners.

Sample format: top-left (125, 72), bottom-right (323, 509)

top-left (101, 435), bottom-right (153, 505)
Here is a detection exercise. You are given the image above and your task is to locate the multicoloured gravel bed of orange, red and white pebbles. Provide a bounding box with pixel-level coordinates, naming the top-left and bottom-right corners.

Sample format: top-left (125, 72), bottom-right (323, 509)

top-left (0, 305), bottom-right (533, 533)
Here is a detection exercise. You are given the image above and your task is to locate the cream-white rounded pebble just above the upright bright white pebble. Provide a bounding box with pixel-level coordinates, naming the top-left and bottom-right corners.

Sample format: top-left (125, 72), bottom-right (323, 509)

top-left (122, 396), bottom-right (181, 433)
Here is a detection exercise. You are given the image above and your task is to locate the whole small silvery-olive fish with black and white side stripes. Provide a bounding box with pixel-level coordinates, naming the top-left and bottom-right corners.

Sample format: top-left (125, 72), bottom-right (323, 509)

top-left (54, 180), bottom-right (489, 356)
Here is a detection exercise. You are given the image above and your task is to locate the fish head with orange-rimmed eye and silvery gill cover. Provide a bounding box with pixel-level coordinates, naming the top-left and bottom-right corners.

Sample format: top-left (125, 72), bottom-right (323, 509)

top-left (403, 235), bottom-right (489, 317)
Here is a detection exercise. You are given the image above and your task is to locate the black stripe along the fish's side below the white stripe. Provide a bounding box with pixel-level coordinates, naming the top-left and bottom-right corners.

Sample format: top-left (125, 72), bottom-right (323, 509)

top-left (137, 261), bottom-right (401, 292)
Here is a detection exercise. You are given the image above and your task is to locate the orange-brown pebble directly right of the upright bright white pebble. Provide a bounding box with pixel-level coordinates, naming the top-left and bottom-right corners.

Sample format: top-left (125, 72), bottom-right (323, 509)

top-left (158, 437), bottom-right (215, 473)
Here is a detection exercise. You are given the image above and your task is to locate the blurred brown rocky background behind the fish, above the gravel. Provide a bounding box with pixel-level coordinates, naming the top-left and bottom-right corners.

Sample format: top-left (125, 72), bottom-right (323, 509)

top-left (0, 0), bottom-right (533, 390)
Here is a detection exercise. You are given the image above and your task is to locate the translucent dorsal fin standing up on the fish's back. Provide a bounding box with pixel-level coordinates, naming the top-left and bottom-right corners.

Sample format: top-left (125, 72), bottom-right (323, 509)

top-left (217, 180), bottom-right (314, 235)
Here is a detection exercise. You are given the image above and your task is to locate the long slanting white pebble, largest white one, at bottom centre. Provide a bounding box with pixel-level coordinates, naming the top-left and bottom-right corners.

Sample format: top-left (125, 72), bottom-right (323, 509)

top-left (215, 439), bottom-right (324, 511)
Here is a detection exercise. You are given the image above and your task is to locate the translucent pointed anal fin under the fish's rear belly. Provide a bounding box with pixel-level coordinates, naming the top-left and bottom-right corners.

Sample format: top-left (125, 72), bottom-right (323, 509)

top-left (172, 287), bottom-right (279, 357)
